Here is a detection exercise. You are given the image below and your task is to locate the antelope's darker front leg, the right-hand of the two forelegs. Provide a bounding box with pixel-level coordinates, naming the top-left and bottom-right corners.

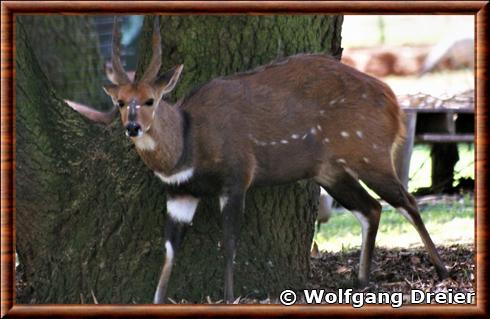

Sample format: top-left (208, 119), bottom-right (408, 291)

top-left (220, 193), bottom-right (245, 303)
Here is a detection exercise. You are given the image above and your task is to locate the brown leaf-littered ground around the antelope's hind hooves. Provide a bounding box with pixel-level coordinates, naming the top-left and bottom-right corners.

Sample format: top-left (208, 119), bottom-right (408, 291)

top-left (161, 244), bottom-right (475, 304)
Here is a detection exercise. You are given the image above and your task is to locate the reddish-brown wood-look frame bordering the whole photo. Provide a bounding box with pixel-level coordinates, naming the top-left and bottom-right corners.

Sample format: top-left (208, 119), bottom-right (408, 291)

top-left (0, 1), bottom-right (490, 318)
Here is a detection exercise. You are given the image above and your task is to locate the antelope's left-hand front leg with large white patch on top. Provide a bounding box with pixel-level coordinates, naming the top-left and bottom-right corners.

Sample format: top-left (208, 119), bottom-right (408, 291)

top-left (153, 196), bottom-right (199, 304)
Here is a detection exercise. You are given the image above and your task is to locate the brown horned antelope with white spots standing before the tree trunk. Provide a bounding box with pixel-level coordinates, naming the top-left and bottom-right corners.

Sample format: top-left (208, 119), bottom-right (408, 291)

top-left (66, 18), bottom-right (448, 303)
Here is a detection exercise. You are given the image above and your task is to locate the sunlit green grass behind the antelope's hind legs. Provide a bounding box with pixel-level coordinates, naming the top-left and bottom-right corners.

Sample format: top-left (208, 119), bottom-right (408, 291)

top-left (315, 144), bottom-right (475, 251)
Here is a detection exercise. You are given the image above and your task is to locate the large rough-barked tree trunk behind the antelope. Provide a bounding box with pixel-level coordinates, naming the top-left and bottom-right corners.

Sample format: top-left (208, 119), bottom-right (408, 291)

top-left (16, 16), bottom-right (342, 303)
